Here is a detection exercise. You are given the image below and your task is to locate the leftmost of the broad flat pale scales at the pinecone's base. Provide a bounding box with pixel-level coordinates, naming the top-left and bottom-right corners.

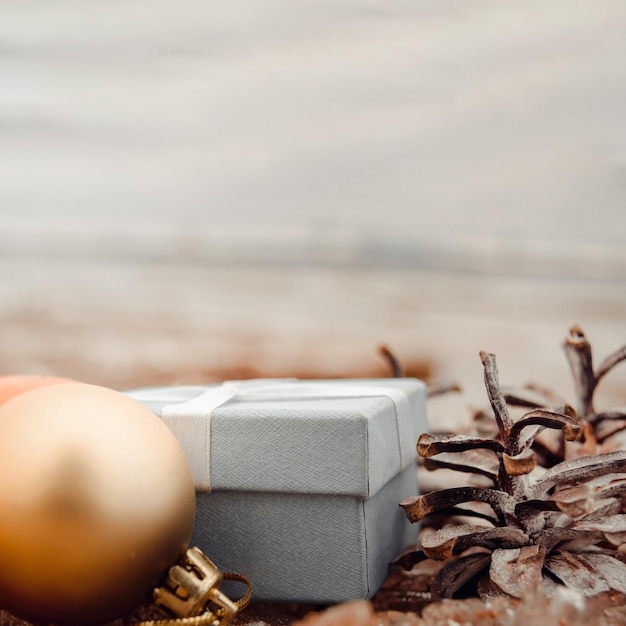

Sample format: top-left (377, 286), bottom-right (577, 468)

top-left (489, 545), bottom-right (546, 598)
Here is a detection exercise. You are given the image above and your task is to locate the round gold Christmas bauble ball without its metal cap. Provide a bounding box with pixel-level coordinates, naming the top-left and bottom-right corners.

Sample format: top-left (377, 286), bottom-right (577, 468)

top-left (0, 383), bottom-right (195, 626)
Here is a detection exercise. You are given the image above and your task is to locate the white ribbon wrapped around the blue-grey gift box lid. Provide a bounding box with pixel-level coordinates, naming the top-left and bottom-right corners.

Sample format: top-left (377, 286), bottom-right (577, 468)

top-left (160, 379), bottom-right (416, 491)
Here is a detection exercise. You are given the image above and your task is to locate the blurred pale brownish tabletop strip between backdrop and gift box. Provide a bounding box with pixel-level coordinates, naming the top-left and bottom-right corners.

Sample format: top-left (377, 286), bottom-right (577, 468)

top-left (0, 259), bottom-right (626, 434)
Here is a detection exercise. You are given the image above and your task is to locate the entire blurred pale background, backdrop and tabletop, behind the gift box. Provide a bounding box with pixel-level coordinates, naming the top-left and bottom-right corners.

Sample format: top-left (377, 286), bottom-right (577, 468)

top-left (0, 0), bottom-right (626, 424)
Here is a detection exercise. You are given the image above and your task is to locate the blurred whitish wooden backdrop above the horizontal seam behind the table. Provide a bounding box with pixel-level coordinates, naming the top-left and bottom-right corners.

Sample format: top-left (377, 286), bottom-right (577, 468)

top-left (0, 0), bottom-right (626, 279)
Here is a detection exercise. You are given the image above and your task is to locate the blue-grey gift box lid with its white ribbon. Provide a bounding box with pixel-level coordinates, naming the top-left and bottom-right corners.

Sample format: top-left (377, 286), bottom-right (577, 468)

top-left (125, 378), bottom-right (427, 497)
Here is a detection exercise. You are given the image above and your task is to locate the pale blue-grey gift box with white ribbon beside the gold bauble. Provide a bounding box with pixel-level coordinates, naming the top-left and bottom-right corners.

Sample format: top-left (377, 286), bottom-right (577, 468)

top-left (126, 378), bottom-right (427, 604)
